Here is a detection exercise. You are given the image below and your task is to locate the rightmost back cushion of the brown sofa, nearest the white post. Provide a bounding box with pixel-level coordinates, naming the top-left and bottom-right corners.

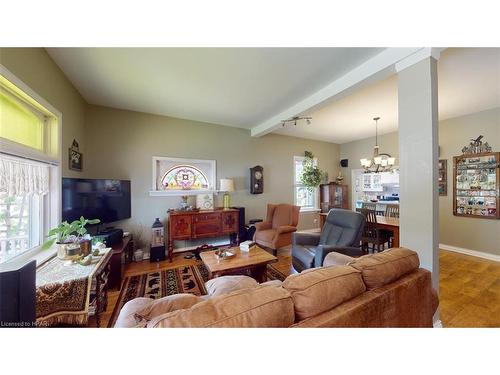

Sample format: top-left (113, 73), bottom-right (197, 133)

top-left (349, 247), bottom-right (420, 290)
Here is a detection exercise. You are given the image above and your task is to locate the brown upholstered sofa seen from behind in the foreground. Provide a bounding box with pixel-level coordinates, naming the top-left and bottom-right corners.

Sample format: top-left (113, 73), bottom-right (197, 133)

top-left (115, 248), bottom-right (438, 328)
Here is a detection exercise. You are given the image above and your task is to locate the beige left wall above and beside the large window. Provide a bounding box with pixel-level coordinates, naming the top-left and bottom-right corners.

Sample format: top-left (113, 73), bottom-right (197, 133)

top-left (0, 48), bottom-right (88, 177)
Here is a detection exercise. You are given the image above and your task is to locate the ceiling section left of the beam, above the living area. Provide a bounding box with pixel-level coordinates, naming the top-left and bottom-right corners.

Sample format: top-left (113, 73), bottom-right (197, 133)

top-left (47, 48), bottom-right (383, 129)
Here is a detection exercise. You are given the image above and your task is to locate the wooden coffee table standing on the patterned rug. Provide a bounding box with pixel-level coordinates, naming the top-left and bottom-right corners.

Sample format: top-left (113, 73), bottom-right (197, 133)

top-left (200, 246), bottom-right (278, 283)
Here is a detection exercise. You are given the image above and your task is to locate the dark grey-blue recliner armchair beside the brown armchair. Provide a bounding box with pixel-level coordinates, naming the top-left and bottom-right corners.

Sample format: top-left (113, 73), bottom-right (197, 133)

top-left (292, 208), bottom-right (365, 272)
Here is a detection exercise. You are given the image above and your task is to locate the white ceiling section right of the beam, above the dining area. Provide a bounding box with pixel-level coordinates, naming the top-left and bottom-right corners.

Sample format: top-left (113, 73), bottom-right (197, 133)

top-left (275, 48), bottom-right (500, 144)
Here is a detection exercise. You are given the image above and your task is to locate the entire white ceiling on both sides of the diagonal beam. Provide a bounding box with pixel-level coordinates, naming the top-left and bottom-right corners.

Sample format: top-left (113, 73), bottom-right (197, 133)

top-left (47, 48), bottom-right (500, 144)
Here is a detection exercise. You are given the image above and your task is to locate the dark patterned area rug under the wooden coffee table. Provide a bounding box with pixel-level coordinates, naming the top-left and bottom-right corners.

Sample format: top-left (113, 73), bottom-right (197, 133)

top-left (108, 263), bottom-right (287, 327)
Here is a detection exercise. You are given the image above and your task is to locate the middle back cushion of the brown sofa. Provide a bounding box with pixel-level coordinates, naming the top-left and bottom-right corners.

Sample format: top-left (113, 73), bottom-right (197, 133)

top-left (283, 266), bottom-right (366, 320)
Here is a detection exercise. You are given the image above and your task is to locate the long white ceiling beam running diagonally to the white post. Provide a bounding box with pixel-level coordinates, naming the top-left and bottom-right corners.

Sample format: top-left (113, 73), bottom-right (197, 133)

top-left (250, 47), bottom-right (436, 137)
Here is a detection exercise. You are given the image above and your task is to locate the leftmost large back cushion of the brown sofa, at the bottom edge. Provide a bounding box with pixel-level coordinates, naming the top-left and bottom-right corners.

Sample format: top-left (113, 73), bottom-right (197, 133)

top-left (147, 285), bottom-right (295, 328)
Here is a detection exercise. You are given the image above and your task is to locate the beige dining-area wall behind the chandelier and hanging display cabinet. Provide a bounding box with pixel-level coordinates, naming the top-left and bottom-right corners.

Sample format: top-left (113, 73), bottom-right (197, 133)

top-left (340, 108), bottom-right (500, 255)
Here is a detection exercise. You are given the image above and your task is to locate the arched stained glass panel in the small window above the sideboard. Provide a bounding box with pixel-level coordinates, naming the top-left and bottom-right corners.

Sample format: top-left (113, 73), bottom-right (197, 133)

top-left (161, 165), bottom-right (209, 190)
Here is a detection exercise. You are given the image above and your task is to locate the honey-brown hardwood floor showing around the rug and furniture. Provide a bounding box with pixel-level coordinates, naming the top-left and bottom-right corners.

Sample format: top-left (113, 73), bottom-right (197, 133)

top-left (89, 247), bottom-right (500, 327)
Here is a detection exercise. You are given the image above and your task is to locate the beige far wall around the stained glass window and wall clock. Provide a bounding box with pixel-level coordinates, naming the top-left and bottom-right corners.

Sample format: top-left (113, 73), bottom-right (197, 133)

top-left (85, 105), bottom-right (339, 238)
